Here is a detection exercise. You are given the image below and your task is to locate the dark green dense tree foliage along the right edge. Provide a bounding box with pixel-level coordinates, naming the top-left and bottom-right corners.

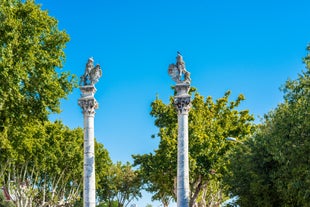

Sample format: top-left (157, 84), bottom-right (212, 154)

top-left (226, 48), bottom-right (310, 207)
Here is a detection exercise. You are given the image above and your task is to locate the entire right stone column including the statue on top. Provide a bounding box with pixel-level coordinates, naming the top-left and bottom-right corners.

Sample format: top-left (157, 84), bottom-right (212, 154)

top-left (168, 53), bottom-right (191, 207)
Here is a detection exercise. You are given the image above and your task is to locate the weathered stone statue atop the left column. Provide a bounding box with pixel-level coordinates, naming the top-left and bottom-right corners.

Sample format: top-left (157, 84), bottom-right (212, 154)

top-left (80, 58), bottom-right (102, 86)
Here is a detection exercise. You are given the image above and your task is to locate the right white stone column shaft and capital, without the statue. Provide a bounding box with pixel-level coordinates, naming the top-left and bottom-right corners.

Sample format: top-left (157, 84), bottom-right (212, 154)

top-left (174, 83), bottom-right (191, 207)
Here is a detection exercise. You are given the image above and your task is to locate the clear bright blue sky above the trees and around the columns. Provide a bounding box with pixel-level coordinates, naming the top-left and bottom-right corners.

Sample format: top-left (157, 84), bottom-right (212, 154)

top-left (37, 0), bottom-right (310, 205)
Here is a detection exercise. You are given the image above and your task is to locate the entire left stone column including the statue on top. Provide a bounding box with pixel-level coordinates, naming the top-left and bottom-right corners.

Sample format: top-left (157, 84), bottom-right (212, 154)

top-left (78, 58), bottom-right (102, 207)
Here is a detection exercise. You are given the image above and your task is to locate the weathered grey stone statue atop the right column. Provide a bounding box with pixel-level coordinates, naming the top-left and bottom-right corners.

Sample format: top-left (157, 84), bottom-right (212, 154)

top-left (168, 52), bottom-right (191, 84)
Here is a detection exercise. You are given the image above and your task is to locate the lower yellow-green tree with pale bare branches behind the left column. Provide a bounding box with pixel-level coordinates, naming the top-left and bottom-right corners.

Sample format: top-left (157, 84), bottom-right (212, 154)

top-left (0, 121), bottom-right (112, 207)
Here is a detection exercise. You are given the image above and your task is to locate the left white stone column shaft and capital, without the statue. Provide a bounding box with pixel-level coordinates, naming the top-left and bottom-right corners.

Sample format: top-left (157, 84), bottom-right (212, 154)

top-left (78, 85), bottom-right (98, 207)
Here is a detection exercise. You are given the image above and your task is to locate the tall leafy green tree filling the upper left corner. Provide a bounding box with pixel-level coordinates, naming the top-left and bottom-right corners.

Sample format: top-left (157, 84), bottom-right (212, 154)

top-left (0, 0), bottom-right (76, 160)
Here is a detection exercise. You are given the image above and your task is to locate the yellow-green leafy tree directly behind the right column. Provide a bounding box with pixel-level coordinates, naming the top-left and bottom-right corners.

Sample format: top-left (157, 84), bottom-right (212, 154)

top-left (133, 89), bottom-right (255, 206)
